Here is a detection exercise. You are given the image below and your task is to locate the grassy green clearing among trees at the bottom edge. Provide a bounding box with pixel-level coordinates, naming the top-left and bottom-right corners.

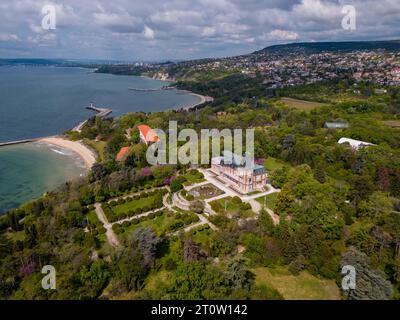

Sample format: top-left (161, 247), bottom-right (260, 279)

top-left (251, 267), bottom-right (340, 300)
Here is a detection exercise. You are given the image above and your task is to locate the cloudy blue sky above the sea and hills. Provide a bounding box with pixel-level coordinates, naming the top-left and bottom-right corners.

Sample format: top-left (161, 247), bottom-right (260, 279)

top-left (0, 0), bottom-right (400, 61)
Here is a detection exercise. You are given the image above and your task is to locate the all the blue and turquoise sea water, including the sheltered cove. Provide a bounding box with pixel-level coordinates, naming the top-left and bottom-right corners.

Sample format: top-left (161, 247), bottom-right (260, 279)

top-left (0, 66), bottom-right (199, 214)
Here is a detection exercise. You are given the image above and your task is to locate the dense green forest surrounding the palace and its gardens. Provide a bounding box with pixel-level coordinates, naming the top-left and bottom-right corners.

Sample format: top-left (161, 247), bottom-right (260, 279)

top-left (0, 75), bottom-right (400, 299)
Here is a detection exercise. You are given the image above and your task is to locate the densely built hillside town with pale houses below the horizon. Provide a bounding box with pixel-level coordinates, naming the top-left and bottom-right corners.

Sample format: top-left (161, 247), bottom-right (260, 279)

top-left (102, 45), bottom-right (400, 89)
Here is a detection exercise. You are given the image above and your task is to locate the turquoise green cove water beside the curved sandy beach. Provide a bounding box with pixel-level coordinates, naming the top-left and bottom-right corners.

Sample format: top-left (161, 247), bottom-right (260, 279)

top-left (0, 143), bottom-right (85, 213)
